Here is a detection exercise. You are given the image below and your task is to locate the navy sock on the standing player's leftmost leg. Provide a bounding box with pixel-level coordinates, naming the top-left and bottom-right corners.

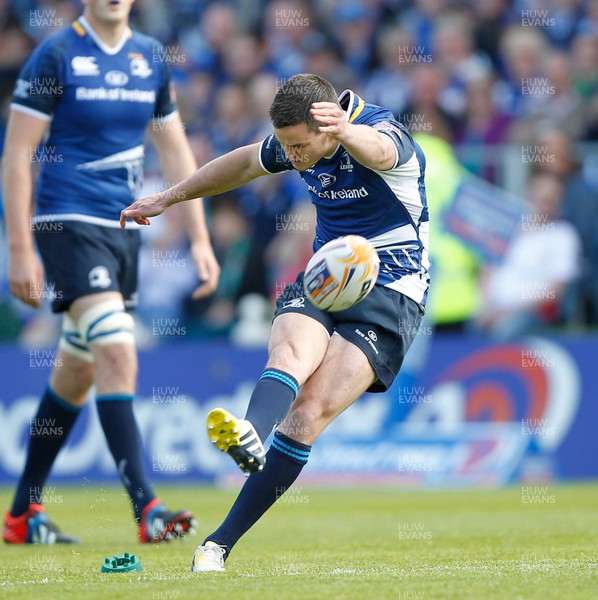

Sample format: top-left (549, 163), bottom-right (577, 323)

top-left (10, 386), bottom-right (81, 517)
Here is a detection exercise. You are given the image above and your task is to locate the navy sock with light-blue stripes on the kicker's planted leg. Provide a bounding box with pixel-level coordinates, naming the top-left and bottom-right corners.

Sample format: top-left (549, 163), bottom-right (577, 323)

top-left (204, 431), bottom-right (311, 557)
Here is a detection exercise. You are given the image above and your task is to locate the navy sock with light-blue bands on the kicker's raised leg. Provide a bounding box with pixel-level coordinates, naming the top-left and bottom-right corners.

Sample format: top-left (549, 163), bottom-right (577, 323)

top-left (245, 369), bottom-right (299, 442)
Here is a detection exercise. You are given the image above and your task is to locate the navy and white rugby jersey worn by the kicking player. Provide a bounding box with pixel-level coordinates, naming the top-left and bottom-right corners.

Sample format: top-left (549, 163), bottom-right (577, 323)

top-left (260, 90), bottom-right (430, 306)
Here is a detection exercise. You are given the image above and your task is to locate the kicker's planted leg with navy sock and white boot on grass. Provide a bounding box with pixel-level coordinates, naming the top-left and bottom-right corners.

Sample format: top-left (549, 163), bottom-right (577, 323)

top-left (191, 335), bottom-right (375, 572)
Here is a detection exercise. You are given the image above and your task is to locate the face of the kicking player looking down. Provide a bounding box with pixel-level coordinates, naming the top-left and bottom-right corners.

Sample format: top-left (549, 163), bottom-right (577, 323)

top-left (274, 123), bottom-right (338, 171)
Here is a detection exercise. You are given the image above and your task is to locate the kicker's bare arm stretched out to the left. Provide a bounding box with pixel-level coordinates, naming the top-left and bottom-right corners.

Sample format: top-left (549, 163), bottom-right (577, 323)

top-left (120, 143), bottom-right (268, 227)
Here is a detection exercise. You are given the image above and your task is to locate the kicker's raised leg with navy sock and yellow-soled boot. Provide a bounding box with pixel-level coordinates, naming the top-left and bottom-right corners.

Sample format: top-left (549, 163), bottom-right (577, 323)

top-left (207, 313), bottom-right (330, 475)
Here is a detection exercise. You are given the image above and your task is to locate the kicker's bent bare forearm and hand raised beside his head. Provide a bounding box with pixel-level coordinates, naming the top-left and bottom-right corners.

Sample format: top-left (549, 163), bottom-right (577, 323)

top-left (311, 102), bottom-right (397, 171)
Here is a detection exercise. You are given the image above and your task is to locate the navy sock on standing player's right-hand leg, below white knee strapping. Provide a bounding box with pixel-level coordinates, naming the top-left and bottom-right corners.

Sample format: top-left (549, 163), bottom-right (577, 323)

top-left (96, 394), bottom-right (155, 523)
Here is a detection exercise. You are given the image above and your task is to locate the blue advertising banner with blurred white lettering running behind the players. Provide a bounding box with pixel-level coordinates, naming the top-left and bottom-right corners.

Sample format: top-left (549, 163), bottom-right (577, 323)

top-left (0, 336), bottom-right (598, 487)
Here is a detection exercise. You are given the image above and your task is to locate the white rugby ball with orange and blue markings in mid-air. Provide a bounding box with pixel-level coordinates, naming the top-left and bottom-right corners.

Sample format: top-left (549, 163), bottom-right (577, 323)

top-left (303, 235), bottom-right (380, 312)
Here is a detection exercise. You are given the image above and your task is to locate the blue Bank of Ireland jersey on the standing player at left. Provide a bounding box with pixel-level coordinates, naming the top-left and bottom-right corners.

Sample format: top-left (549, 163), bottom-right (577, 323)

top-left (11, 17), bottom-right (176, 227)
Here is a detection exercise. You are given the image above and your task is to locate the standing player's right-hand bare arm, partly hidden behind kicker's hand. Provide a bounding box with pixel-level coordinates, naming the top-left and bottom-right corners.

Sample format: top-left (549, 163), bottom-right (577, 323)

top-left (149, 112), bottom-right (220, 298)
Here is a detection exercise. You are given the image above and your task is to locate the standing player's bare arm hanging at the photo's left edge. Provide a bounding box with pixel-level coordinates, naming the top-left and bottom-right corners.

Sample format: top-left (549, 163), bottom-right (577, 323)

top-left (2, 109), bottom-right (48, 307)
